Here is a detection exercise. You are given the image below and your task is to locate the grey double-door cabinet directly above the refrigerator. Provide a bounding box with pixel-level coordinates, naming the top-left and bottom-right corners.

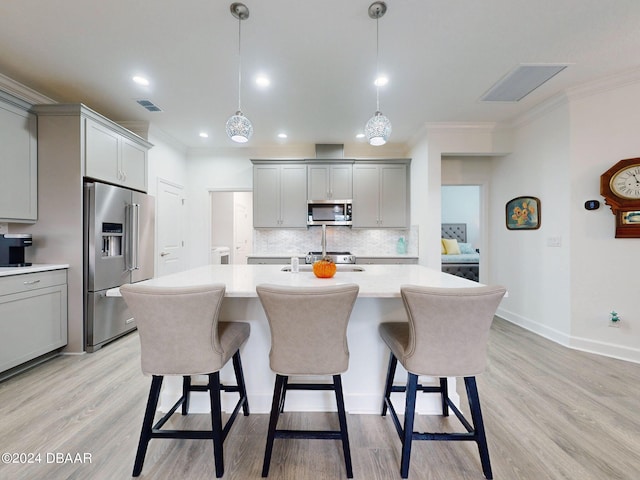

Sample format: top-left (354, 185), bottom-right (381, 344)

top-left (85, 118), bottom-right (148, 192)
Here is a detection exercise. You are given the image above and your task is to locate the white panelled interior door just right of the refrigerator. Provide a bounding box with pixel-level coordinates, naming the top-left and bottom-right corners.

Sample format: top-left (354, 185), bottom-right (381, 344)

top-left (156, 179), bottom-right (186, 276)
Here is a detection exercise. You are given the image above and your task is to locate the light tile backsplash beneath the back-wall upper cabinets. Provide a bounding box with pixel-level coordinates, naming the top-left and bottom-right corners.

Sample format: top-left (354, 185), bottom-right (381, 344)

top-left (253, 225), bottom-right (418, 257)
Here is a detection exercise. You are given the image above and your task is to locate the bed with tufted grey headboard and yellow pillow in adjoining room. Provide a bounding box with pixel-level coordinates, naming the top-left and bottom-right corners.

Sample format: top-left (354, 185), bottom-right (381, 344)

top-left (441, 223), bottom-right (480, 282)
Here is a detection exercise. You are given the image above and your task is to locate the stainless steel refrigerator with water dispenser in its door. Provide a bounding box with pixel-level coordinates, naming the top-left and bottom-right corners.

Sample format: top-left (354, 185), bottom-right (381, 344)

top-left (84, 182), bottom-right (155, 352)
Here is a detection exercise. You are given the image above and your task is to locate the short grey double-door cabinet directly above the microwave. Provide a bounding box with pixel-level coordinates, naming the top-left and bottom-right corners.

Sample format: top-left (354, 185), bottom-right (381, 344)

top-left (307, 163), bottom-right (353, 202)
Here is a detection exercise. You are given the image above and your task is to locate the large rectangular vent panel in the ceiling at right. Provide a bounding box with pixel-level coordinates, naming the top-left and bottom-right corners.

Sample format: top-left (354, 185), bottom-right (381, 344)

top-left (480, 64), bottom-right (568, 102)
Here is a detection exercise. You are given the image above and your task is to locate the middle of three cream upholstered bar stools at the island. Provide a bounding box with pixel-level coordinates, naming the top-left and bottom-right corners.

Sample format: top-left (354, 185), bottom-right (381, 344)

top-left (256, 284), bottom-right (359, 478)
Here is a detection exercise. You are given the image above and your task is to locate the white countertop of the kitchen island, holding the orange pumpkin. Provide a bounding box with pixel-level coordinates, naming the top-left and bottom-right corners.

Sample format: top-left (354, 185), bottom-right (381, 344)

top-left (107, 265), bottom-right (481, 298)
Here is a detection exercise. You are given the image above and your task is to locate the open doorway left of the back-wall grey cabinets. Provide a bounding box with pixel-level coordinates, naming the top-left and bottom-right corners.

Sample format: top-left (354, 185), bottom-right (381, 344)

top-left (209, 190), bottom-right (253, 264)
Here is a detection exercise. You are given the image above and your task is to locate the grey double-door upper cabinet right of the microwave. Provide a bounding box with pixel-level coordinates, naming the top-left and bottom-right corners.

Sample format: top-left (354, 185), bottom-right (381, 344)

top-left (353, 160), bottom-right (410, 228)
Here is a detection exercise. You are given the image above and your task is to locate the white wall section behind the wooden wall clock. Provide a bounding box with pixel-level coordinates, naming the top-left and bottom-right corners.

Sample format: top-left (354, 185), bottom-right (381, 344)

top-left (568, 79), bottom-right (640, 362)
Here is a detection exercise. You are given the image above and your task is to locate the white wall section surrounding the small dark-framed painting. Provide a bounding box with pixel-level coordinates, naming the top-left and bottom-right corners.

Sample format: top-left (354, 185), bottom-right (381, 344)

top-left (489, 102), bottom-right (571, 344)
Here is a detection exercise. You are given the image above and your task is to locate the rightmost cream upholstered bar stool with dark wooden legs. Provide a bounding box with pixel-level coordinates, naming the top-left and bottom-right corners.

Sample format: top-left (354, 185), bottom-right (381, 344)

top-left (379, 285), bottom-right (506, 479)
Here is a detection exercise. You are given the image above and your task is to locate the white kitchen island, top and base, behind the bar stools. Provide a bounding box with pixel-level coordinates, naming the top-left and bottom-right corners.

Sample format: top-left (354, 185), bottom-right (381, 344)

top-left (108, 265), bottom-right (488, 414)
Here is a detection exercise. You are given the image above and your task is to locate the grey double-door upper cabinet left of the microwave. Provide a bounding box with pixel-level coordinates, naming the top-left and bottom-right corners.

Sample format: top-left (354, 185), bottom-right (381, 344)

top-left (253, 163), bottom-right (307, 228)
